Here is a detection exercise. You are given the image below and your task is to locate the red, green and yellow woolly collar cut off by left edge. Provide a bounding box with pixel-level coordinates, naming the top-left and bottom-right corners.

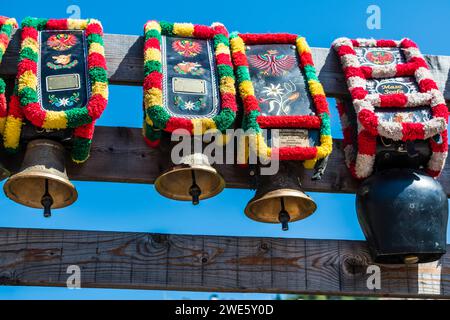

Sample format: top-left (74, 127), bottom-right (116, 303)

top-left (0, 16), bottom-right (17, 135)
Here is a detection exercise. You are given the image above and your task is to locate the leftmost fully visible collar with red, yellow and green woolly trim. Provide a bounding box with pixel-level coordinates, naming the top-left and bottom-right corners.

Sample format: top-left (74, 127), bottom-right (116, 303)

top-left (4, 18), bottom-right (108, 162)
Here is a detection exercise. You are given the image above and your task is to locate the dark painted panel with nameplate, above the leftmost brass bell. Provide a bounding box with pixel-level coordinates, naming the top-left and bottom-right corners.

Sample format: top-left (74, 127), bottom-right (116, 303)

top-left (38, 30), bottom-right (90, 111)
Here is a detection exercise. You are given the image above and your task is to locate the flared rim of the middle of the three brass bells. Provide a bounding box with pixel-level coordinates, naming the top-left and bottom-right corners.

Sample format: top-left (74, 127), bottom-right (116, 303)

top-left (155, 164), bottom-right (225, 201)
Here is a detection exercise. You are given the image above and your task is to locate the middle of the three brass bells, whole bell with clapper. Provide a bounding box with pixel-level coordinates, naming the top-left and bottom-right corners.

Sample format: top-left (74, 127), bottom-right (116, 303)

top-left (155, 153), bottom-right (225, 205)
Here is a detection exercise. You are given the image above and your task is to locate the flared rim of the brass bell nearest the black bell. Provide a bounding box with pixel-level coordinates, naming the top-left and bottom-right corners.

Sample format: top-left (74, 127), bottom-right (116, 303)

top-left (244, 189), bottom-right (317, 224)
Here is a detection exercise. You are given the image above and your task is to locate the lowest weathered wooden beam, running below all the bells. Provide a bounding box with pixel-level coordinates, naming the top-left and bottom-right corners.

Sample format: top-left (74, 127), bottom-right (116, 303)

top-left (0, 228), bottom-right (450, 298)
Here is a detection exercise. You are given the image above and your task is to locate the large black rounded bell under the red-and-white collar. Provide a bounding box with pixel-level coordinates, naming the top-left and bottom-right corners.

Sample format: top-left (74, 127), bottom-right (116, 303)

top-left (356, 169), bottom-right (448, 264)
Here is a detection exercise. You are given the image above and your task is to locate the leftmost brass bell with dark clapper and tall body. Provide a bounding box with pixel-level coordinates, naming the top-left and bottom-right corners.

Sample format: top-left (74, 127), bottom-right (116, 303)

top-left (3, 139), bottom-right (78, 217)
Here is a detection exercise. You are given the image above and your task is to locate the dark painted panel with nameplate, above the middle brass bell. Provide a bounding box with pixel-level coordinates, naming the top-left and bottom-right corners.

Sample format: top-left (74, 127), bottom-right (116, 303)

top-left (161, 37), bottom-right (220, 119)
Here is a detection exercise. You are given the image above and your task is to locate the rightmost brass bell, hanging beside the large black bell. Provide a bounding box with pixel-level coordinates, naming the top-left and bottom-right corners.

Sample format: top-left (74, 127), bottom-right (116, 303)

top-left (245, 162), bottom-right (317, 231)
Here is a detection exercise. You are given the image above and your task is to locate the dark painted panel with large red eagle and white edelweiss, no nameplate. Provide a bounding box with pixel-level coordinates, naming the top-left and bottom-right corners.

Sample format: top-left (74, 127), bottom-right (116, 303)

top-left (246, 44), bottom-right (315, 116)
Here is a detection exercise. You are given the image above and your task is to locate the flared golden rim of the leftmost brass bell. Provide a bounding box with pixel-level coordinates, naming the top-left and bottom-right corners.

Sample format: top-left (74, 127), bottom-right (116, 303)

top-left (3, 172), bottom-right (78, 209)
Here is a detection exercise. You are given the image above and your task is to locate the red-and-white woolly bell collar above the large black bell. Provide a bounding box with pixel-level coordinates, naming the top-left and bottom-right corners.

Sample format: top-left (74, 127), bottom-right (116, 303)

top-left (333, 38), bottom-right (448, 179)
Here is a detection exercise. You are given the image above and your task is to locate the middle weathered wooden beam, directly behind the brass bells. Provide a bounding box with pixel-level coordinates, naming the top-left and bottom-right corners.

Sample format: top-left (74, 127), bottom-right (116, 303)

top-left (0, 127), bottom-right (450, 195)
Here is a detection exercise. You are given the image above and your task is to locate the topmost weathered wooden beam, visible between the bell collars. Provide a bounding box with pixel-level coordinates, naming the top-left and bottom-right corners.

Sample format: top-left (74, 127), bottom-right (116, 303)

top-left (0, 31), bottom-right (450, 101)
